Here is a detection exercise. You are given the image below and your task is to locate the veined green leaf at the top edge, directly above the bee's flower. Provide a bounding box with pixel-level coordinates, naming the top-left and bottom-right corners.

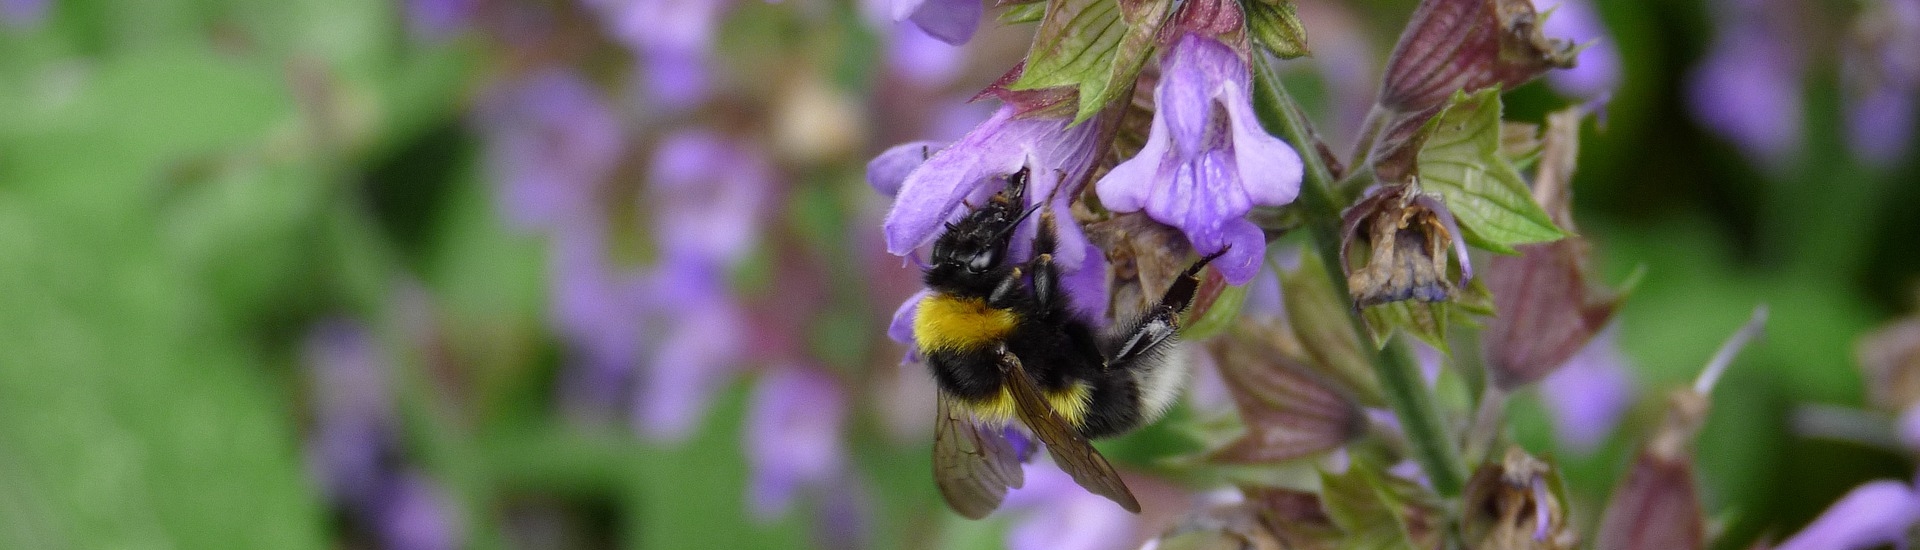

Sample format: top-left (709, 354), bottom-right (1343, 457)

top-left (1008, 0), bottom-right (1169, 123)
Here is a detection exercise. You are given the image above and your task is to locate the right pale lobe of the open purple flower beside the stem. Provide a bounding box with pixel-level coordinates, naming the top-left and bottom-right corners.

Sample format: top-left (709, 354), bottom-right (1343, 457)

top-left (1221, 85), bottom-right (1305, 207)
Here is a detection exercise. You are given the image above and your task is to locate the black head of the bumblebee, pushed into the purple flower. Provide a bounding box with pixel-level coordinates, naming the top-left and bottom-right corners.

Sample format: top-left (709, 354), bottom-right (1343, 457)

top-left (927, 167), bottom-right (1039, 287)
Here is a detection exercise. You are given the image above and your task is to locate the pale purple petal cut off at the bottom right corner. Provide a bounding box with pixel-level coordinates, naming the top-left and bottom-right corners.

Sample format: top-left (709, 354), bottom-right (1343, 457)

top-left (1774, 481), bottom-right (1920, 550)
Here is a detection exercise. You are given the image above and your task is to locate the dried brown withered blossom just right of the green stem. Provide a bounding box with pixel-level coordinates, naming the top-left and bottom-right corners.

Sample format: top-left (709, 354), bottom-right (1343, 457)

top-left (1340, 185), bottom-right (1473, 306)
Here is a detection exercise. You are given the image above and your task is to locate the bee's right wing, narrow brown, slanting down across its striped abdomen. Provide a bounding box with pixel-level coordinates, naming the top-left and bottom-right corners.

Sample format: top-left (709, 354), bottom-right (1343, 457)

top-left (1000, 354), bottom-right (1140, 513)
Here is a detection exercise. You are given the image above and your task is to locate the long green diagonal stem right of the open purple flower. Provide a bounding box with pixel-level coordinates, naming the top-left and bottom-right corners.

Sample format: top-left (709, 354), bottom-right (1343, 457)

top-left (1254, 55), bottom-right (1467, 496)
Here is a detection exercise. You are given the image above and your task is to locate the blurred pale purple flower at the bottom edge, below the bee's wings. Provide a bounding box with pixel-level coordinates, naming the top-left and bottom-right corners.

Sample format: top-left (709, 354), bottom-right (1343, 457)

top-left (1004, 465), bottom-right (1139, 550)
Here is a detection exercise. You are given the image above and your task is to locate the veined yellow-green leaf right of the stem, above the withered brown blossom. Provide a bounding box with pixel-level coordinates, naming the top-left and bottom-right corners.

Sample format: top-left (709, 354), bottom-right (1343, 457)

top-left (1419, 87), bottom-right (1567, 254)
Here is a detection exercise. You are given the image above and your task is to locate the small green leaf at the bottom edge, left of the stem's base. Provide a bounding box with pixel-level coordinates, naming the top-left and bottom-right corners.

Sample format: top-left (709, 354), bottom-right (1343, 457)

top-left (1321, 460), bottom-right (1438, 550)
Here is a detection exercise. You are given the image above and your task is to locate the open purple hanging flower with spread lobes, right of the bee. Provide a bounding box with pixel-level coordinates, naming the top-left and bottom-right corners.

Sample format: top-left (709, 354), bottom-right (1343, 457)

top-left (1096, 35), bottom-right (1302, 285)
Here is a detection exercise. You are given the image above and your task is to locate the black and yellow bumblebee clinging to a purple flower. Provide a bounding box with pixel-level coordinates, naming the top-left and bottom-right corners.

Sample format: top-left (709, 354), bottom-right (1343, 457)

top-left (914, 167), bottom-right (1225, 519)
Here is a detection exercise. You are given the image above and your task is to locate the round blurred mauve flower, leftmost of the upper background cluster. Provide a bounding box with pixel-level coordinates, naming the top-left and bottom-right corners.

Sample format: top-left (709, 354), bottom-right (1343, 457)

top-left (480, 69), bottom-right (624, 229)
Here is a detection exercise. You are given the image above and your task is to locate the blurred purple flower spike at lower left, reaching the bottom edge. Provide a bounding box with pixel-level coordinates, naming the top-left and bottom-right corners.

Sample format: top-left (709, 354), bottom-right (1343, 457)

top-left (303, 319), bottom-right (461, 548)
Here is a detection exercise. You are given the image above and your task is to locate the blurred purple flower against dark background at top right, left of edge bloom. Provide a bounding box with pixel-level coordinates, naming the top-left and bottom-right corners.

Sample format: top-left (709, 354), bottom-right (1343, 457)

top-left (1688, 0), bottom-right (1803, 169)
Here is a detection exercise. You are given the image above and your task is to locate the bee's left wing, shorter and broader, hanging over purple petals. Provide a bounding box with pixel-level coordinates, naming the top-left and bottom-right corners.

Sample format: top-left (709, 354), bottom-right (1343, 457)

top-left (933, 392), bottom-right (1025, 519)
